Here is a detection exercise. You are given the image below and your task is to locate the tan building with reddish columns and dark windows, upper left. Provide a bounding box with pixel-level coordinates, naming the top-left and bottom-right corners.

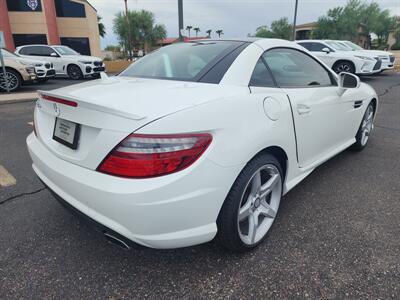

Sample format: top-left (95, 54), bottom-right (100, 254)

top-left (0, 0), bottom-right (100, 56)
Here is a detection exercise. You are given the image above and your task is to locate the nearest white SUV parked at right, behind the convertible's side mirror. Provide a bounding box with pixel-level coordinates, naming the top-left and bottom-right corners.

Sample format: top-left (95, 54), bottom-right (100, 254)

top-left (296, 40), bottom-right (382, 75)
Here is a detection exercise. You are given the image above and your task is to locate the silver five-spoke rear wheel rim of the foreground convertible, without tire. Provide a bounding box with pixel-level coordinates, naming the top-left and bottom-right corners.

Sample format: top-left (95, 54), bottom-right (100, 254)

top-left (237, 164), bottom-right (282, 246)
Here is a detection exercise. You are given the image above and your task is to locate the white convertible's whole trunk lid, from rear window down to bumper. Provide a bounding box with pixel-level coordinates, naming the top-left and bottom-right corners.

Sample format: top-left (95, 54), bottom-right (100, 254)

top-left (35, 77), bottom-right (244, 169)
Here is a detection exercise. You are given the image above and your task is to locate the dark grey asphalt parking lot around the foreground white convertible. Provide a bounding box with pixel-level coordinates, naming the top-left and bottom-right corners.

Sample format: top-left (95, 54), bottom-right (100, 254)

top-left (0, 72), bottom-right (400, 299)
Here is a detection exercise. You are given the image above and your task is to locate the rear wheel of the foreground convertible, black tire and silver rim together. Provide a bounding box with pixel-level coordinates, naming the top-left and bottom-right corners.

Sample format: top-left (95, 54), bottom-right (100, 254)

top-left (217, 154), bottom-right (283, 252)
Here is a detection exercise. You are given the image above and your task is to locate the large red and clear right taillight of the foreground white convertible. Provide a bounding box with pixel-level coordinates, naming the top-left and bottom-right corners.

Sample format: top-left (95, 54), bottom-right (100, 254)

top-left (97, 133), bottom-right (212, 178)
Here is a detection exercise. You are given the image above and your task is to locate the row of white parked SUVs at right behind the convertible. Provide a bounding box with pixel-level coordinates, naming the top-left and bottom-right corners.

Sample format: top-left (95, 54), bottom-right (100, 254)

top-left (297, 40), bottom-right (395, 75)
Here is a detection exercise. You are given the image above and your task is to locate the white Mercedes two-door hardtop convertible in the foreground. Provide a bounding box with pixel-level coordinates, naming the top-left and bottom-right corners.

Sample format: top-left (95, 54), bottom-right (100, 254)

top-left (27, 39), bottom-right (378, 251)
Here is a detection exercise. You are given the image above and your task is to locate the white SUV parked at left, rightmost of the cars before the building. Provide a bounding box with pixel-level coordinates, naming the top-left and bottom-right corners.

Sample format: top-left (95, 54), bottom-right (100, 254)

top-left (15, 45), bottom-right (105, 80)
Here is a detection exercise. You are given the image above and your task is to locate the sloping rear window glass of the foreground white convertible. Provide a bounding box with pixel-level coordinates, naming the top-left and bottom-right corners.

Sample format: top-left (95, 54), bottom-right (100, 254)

top-left (120, 41), bottom-right (242, 81)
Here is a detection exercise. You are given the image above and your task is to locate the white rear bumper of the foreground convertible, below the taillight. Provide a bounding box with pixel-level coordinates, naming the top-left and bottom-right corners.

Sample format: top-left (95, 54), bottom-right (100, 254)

top-left (27, 134), bottom-right (241, 248)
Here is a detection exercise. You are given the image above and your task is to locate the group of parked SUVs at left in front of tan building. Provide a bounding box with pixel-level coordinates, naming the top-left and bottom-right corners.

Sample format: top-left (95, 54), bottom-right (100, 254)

top-left (0, 45), bottom-right (105, 91)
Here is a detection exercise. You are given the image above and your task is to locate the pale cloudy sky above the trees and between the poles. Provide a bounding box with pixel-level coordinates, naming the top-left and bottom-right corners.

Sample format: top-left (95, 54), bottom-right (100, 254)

top-left (89, 0), bottom-right (400, 47)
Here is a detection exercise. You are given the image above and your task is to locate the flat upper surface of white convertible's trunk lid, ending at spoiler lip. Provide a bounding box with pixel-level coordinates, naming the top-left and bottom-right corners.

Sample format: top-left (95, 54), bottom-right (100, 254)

top-left (45, 76), bottom-right (245, 120)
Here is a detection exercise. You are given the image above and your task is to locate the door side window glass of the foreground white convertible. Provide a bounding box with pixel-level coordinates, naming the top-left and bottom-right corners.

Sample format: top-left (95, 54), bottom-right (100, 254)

top-left (263, 48), bottom-right (336, 87)
